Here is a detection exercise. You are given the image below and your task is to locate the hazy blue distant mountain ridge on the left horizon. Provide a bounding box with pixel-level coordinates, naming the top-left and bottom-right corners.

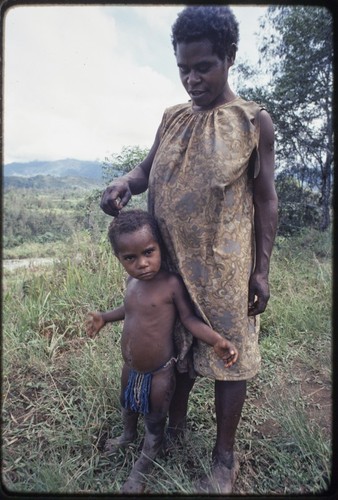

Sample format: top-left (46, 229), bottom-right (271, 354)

top-left (3, 158), bottom-right (102, 181)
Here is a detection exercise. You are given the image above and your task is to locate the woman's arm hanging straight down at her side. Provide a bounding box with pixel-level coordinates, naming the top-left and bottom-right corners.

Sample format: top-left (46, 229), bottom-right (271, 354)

top-left (249, 110), bottom-right (278, 316)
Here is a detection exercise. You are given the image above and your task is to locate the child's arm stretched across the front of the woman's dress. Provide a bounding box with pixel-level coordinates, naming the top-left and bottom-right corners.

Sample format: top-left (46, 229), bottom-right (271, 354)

top-left (170, 276), bottom-right (238, 368)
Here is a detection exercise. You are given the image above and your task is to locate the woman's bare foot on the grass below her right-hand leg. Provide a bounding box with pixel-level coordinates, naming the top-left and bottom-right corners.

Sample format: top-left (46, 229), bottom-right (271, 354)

top-left (196, 457), bottom-right (239, 495)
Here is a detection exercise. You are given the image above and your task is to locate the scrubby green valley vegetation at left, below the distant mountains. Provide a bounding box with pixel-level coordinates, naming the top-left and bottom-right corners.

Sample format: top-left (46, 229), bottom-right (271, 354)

top-left (3, 185), bottom-right (108, 252)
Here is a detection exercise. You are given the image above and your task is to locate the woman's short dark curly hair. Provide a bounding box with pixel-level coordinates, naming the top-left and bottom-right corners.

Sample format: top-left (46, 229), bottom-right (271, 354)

top-left (171, 5), bottom-right (239, 61)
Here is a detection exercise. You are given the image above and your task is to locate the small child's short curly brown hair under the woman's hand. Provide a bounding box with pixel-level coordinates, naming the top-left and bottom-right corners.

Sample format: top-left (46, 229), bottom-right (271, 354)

top-left (108, 209), bottom-right (162, 255)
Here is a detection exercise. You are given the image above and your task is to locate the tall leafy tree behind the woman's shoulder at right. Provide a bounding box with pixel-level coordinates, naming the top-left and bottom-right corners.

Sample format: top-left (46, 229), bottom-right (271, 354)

top-left (236, 6), bottom-right (333, 230)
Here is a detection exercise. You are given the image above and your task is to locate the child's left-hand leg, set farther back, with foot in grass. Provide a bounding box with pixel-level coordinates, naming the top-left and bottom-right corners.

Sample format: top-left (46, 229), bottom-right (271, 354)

top-left (104, 365), bottom-right (139, 454)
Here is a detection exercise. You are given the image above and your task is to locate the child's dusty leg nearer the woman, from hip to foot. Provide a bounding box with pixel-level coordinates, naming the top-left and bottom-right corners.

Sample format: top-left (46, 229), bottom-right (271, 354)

top-left (122, 365), bottom-right (175, 493)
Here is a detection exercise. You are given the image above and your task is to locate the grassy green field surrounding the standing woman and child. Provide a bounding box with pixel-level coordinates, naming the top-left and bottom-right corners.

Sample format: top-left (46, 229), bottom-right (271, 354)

top-left (2, 188), bottom-right (332, 495)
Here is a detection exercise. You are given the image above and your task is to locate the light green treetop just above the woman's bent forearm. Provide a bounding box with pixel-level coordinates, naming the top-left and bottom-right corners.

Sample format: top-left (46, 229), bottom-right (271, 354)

top-left (102, 146), bottom-right (149, 182)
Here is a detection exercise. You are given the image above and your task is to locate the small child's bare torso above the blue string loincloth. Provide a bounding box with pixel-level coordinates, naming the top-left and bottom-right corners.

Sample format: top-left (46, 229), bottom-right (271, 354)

top-left (121, 271), bottom-right (177, 372)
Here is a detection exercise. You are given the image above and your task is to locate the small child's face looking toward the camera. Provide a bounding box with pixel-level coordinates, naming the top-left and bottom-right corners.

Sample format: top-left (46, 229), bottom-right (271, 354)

top-left (117, 226), bottom-right (161, 281)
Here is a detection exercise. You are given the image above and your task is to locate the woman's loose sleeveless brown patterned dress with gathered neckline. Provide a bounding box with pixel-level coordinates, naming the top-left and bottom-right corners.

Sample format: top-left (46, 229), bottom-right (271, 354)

top-left (148, 97), bottom-right (261, 380)
